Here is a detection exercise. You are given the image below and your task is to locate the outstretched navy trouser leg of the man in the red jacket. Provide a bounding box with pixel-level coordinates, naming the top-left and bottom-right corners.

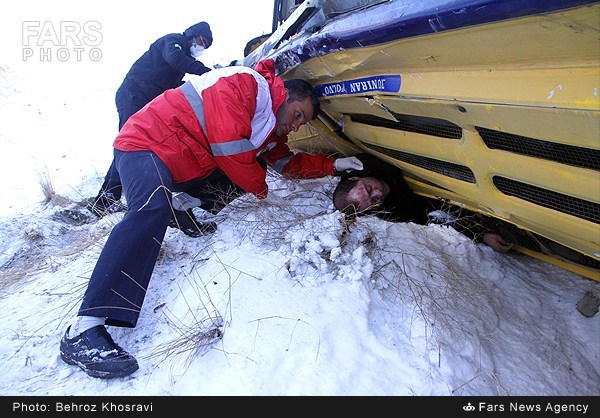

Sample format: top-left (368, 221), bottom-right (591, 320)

top-left (79, 150), bottom-right (173, 327)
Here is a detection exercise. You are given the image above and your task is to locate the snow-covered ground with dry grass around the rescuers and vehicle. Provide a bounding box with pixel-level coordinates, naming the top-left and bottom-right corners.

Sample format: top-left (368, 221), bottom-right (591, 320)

top-left (0, 0), bottom-right (600, 397)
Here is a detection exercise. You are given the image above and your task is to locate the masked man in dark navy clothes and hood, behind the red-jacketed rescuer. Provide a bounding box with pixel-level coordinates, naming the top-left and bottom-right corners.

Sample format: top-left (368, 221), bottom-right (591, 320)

top-left (88, 22), bottom-right (213, 222)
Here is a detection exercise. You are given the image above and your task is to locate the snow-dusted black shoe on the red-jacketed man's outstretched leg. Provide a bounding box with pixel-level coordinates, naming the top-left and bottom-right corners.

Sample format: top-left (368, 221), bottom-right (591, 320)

top-left (60, 325), bottom-right (139, 379)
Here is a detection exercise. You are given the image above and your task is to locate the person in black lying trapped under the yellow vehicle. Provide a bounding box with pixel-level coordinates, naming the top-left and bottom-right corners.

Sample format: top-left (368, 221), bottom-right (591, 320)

top-left (333, 153), bottom-right (513, 253)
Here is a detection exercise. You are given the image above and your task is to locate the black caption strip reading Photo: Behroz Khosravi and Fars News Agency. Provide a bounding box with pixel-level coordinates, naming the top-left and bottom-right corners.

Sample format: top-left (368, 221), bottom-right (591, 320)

top-left (0, 396), bottom-right (600, 417)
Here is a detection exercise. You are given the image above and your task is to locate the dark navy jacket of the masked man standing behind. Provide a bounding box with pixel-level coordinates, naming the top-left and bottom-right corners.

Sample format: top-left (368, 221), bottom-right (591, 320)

top-left (121, 33), bottom-right (210, 103)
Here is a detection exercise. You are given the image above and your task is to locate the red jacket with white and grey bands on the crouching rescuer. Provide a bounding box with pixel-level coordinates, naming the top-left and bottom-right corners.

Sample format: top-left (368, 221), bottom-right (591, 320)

top-left (114, 60), bottom-right (334, 198)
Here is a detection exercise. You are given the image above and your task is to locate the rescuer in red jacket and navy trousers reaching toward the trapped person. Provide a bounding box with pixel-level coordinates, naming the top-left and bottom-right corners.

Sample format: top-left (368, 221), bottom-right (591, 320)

top-left (60, 60), bottom-right (362, 379)
